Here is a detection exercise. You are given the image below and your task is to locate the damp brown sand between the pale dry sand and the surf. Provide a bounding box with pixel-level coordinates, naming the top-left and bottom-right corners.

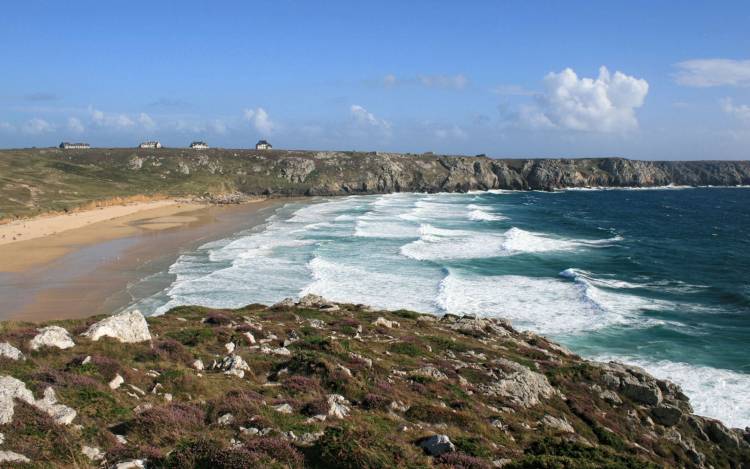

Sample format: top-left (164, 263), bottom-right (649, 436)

top-left (0, 199), bottom-right (289, 321)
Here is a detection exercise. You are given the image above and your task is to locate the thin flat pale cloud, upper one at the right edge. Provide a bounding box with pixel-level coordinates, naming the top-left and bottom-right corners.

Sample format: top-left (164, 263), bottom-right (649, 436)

top-left (675, 59), bottom-right (750, 88)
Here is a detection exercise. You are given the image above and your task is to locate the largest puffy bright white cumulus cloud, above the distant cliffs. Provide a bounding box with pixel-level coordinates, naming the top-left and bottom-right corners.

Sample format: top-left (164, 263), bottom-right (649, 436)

top-left (518, 67), bottom-right (648, 132)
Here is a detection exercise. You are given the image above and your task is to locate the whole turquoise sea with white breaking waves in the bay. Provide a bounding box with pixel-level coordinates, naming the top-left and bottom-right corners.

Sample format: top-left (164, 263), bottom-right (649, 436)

top-left (139, 188), bottom-right (750, 427)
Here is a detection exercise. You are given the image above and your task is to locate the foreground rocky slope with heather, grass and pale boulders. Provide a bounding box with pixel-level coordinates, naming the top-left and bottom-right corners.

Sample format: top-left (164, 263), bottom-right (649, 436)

top-left (0, 295), bottom-right (750, 469)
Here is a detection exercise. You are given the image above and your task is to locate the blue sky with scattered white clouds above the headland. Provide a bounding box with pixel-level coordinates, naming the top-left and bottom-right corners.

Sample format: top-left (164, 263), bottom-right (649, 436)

top-left (0, 0), bottom-right (750, 159)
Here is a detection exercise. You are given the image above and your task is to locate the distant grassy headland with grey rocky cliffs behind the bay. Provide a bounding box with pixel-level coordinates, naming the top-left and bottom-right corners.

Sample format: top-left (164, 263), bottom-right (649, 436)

top-left (0, 149), bottom-right (750, 219)
